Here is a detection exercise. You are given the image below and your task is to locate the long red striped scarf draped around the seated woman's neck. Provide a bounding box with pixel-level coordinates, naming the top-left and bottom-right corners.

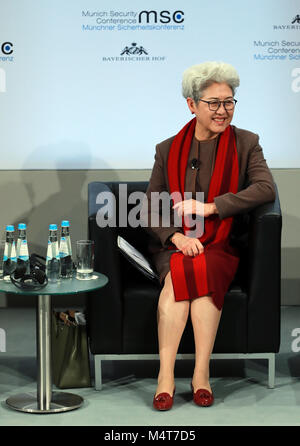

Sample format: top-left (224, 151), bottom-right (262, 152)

top-left (168, 118), bottom-right (239, 309)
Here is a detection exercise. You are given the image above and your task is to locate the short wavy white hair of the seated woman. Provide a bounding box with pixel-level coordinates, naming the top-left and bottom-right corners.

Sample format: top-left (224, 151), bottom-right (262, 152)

top-left (182, 62), bottom-right (240, 103)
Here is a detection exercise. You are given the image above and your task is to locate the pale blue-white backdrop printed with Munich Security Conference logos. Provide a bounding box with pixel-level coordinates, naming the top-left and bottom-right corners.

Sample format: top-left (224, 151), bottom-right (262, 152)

top-left (0, 0), bottom-right (300, 169)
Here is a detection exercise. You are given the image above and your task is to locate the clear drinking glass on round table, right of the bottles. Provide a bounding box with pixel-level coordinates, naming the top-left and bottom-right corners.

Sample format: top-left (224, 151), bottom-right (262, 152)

top-left (76, 240), bottom-right (95, 280)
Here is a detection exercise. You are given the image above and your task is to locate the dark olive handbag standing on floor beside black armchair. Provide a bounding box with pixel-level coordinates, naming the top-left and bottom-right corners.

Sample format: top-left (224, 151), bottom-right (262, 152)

top-left (51, 312), bottom-right (91, 389)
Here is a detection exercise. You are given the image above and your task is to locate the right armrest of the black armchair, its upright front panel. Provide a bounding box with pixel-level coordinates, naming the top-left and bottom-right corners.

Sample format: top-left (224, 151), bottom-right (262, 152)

top-left (248, 185), bottom-right (282, 352)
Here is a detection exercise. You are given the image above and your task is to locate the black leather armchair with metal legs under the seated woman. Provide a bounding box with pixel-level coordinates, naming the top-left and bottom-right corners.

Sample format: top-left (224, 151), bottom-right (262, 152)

top-left (87, 182), bottom-right (282, 390)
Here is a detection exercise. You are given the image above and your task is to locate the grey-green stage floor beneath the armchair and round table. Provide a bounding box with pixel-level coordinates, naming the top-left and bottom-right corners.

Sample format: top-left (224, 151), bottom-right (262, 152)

top-left (0, 306), bottom-right (300, 426)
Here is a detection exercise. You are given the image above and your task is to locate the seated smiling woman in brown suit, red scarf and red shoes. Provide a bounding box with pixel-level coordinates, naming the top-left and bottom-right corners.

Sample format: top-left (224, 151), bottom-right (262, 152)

top-left (142, 62), bottom-right (275, 410)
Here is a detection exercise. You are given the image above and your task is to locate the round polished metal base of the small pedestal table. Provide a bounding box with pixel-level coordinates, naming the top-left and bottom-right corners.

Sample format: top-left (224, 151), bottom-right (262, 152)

top-left (6, 392), bottom-right (83, 413)
